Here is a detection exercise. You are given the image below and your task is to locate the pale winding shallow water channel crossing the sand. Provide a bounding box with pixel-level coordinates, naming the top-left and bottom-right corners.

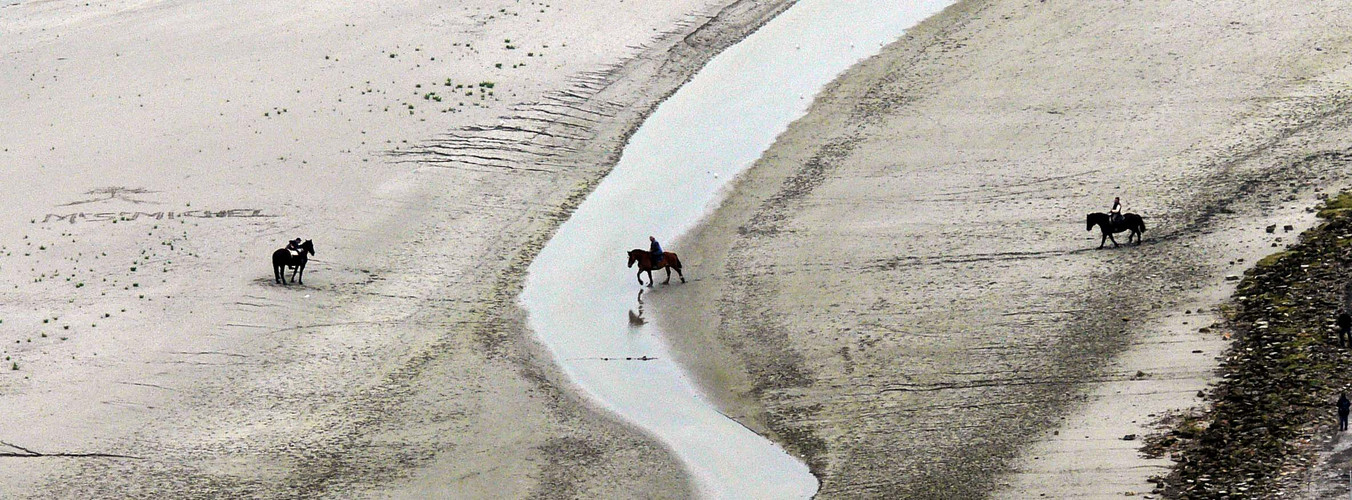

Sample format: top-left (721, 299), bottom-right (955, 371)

top-left (521, 0), bottom-right (953, 499)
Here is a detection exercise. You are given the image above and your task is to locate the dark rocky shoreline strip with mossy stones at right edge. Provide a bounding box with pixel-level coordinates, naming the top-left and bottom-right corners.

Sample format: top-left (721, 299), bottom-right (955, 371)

top-left (1145, 193), bottom-right (1352, 499)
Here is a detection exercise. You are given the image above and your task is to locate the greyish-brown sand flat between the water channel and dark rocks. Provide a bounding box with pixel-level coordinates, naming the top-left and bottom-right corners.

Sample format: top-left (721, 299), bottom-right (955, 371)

top-left (648, 0), bottom-right (1352, 499)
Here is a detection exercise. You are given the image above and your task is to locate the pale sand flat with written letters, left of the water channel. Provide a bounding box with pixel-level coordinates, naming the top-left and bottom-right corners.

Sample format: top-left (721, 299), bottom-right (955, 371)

top-left (0, 0), bottom-right (788, 497)
